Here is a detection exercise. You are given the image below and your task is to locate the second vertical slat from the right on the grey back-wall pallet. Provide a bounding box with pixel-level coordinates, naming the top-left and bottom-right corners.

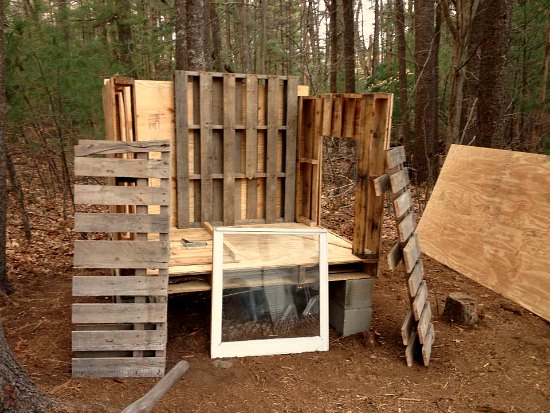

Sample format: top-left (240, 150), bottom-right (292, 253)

top-left (264, 76), bottom-right (279, 224)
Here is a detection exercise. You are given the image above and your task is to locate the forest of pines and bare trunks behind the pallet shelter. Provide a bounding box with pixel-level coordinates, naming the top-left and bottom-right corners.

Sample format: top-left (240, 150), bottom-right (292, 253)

top-left (4, 0), bottom-right (550, 204)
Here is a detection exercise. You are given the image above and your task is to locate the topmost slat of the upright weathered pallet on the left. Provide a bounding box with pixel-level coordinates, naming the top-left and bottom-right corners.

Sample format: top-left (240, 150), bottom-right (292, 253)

top-left (74, 139), bottom-right (170, 157)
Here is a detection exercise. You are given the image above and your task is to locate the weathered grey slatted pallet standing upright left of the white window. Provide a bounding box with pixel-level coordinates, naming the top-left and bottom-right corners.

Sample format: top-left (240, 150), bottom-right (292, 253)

top-left (72, 140), bottom-right (170, 377)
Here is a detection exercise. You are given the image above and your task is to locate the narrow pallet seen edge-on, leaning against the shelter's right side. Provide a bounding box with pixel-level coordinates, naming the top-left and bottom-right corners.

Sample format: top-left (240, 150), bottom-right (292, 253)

top-left (374, 146), bottom-right (435, 367)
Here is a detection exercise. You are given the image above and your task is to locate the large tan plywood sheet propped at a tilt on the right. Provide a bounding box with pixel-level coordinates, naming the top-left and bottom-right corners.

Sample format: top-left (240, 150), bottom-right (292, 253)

top-left (417, 145), bottom-right (550, 320)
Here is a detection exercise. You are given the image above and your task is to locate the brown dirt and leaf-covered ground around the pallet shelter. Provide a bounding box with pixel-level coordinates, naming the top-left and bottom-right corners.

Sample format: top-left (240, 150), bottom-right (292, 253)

top-left (0, 155), bottom-right (550, 413)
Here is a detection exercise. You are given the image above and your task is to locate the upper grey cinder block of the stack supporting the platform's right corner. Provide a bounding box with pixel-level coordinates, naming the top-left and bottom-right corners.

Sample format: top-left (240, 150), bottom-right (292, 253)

top-left (329, 278), bottom-right (375, 310)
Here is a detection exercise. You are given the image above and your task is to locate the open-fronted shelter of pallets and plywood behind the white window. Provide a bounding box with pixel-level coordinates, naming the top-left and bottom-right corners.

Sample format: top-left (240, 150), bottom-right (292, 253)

top-left (98, 72), bottom-right (392, 293)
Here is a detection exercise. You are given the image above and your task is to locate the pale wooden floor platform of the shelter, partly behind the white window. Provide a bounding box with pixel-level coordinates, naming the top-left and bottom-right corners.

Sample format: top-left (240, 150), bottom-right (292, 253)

top-left (163, 223), bottom-right (370, 294)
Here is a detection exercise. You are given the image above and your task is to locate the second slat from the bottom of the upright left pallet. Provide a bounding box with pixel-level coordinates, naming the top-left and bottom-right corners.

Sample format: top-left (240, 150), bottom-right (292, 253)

top-left (72, 330), bottom-right (166, 351)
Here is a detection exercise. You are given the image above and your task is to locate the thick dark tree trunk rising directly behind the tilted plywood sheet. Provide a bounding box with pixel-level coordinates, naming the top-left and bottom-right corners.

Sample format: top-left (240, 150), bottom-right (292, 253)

top-left (474, 0), bottom-right (512, 148)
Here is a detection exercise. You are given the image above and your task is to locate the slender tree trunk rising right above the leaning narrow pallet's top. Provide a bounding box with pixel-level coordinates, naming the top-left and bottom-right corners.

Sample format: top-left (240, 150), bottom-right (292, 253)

top-left (395, 0), bottom-right (411, 146)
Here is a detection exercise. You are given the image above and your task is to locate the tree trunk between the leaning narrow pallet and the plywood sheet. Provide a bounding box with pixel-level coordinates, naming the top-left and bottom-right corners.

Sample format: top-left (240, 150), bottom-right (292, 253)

top-left (412, 0), bottom-right (439, 183)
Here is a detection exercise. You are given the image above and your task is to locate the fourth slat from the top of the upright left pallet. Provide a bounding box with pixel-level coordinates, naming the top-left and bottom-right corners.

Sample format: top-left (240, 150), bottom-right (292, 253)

top-left (74, 212), bottom-right (169, 232)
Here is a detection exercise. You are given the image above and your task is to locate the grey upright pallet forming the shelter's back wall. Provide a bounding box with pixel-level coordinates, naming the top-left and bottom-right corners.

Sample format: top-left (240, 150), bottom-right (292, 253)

top-left (174, 71), bottom-right (298, 228)
